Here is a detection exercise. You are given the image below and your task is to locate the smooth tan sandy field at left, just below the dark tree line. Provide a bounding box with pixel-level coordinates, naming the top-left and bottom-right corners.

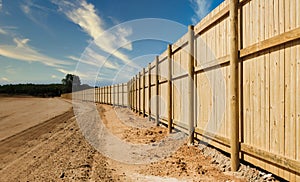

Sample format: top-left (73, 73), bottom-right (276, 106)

top-left (0, 97), bottom-right (72, 141)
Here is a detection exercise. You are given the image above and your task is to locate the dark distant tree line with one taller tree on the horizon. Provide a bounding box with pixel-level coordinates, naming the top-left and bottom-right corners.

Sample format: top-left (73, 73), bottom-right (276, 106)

top-left (0, 74), bottom-right (92, 97)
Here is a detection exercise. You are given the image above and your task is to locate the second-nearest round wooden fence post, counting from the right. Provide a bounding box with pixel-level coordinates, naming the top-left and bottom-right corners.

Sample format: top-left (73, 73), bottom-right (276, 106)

top-left (187, 25), bottom-right (195, 145)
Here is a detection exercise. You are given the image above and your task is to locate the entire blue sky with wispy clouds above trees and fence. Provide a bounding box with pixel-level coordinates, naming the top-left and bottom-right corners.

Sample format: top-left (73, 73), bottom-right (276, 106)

top-left (0, 0), bottom-right (222, 85)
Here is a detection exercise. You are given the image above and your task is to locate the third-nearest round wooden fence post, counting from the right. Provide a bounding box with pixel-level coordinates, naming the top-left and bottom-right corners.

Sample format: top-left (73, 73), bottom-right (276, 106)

top-left (167, 44), bottom-right (173, 133)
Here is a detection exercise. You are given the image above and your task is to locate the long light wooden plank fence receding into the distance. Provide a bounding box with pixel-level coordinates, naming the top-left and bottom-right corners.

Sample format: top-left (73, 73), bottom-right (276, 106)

top-left (61, 0), bottom-right (300, 181)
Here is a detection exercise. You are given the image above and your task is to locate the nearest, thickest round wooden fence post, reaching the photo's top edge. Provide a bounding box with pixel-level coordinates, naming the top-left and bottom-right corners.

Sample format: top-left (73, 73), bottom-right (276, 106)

top-left (229, 0), bottom-right (240, 171)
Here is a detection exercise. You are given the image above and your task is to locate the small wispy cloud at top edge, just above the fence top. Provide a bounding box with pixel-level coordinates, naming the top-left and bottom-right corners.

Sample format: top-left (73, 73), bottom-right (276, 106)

top-left (190, 0), bottom-right (211, 24)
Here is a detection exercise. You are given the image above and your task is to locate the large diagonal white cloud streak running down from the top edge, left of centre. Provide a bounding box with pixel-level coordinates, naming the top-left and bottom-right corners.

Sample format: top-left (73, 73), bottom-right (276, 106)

top-left (52, 0), bottom-right (132, 67)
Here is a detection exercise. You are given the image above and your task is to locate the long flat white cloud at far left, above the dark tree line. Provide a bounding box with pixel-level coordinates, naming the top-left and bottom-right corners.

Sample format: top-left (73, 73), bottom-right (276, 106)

top-left (0, 38), bottom-right (71, 67)
